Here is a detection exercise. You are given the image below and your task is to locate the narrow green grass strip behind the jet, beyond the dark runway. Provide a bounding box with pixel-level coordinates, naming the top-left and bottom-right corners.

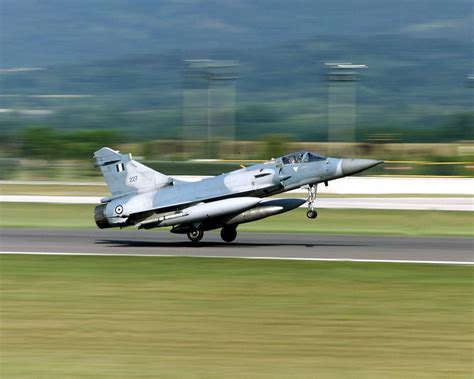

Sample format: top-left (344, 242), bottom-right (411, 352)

top-left (0, 203), bottom-right (474, 236)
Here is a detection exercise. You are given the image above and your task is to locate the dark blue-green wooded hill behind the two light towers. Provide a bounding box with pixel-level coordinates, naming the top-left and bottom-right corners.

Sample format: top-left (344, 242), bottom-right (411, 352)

top-left (0, 34), bottom-right (473, 141)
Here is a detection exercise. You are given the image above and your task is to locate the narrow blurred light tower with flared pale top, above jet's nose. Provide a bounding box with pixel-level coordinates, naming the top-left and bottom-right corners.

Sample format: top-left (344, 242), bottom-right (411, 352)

top-left (324, 62), bottom-right (367, 154)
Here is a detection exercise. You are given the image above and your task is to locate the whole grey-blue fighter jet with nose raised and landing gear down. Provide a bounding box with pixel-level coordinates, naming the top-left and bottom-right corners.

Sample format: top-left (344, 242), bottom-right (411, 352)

top-left (94, 147), bottom-right (382, 242)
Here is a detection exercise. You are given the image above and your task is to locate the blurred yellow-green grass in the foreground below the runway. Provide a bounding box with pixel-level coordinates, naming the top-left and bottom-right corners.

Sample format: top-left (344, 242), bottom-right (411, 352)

top-left (0, 255), bottom-right (474, 379)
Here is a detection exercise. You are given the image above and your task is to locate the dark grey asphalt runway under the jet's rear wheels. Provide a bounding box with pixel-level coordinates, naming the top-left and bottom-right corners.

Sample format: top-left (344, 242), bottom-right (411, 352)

top-left (0, 229), bottom-right (474, 265)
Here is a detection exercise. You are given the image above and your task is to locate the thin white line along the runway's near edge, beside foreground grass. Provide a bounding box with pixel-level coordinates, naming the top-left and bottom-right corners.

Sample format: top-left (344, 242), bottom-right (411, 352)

top-left (0, 251), bottom-right (474, 266)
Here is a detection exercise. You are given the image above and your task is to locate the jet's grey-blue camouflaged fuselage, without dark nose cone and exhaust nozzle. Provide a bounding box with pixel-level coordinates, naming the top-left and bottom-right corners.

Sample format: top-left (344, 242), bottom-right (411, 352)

top-left (102, 153), bottom-right (343, 221)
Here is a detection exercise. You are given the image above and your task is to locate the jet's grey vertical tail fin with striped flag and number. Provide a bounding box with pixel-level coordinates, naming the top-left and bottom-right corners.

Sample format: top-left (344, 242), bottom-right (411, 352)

top-left (94, 147), bottom-right (173, 196)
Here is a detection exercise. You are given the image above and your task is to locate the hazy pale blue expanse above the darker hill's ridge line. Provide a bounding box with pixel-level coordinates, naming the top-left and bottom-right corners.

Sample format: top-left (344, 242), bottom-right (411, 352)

top-left (0, 0), bottom-right (474, 67)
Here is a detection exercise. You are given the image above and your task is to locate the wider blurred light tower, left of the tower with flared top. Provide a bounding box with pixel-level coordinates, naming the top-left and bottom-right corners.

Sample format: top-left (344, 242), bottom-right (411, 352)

top-left (183, 59), bottom-right (239, 158)
